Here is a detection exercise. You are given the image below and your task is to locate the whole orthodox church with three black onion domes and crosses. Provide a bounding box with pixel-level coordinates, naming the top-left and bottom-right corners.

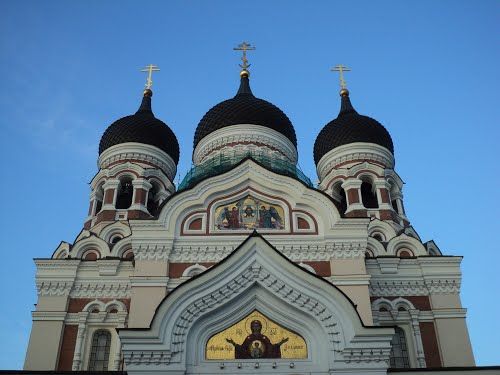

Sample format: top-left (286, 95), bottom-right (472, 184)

top-left (24, 43), bottom-right (488, 375)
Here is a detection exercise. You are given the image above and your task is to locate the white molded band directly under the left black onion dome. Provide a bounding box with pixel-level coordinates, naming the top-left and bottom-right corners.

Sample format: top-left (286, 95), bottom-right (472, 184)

top-left (97, 142), bottom-right (177, 181)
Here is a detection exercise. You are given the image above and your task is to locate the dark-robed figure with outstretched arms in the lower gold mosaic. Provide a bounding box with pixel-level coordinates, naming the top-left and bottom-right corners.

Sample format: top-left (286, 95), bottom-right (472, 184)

top-left (226, 320), bottom-right (288, 359)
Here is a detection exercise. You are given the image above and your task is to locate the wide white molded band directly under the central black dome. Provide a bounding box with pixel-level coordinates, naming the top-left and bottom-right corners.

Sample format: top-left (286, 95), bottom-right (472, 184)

top-left (193, 124), bottom-right (297, 165)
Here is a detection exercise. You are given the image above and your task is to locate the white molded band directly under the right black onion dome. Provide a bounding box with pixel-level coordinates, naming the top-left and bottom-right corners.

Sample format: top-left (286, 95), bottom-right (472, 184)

top-left (316, 142), bottom-right (394, 187)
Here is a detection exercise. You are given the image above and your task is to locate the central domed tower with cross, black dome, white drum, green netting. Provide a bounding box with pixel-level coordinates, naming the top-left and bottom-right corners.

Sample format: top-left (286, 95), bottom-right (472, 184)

top-left (179, 42), bottom-right (310, 189)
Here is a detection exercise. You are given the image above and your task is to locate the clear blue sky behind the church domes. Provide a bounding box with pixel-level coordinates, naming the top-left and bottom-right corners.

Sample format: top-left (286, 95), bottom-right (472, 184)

top-left (0, 0), bottom-right (500, 369)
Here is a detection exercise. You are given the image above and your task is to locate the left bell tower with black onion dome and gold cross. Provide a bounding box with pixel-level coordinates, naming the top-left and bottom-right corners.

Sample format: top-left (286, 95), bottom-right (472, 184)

top-left (85, 65), bottom-right (179, 229)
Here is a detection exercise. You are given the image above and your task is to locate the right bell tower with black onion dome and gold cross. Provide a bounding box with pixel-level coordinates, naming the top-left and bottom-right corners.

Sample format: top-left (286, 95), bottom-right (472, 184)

top-left (314, 65), bottom-right (409, 227)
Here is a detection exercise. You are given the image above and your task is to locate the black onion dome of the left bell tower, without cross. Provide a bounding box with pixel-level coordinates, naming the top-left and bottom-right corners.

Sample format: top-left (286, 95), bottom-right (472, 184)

top-left (99, 90), bottom-right (179, 164)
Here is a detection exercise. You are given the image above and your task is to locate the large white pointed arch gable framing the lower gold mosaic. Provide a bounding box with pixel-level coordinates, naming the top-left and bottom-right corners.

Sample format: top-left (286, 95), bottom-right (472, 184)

top-left (119, 234), bottom-right (394, 374)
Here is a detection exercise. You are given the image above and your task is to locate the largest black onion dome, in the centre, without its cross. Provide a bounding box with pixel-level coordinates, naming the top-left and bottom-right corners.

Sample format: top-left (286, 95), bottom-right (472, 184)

top-left (193, 74), bottom-right (297, 148)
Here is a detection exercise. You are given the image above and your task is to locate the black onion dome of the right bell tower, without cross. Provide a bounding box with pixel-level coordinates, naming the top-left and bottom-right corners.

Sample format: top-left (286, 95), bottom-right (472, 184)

top-left (314, 90), bottom-right (394, 164)
